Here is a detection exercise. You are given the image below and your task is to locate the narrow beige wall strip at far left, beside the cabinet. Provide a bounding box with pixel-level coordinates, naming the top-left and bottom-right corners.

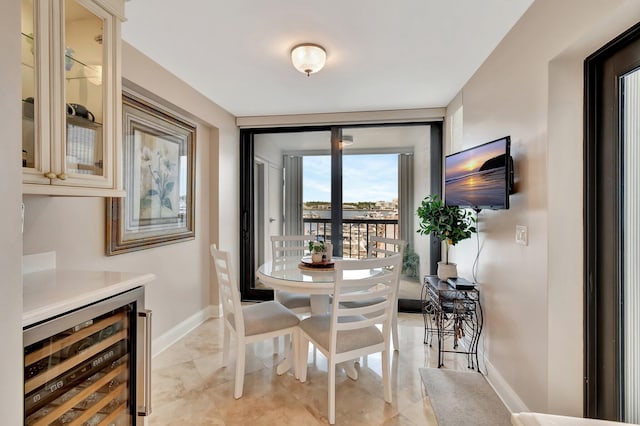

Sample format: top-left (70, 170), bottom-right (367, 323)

top-left (0, 1), bottom-right (23, 425)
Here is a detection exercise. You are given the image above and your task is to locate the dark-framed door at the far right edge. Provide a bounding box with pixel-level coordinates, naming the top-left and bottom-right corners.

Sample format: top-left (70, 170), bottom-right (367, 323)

top-left (585, 21), bottom-right (640, 422)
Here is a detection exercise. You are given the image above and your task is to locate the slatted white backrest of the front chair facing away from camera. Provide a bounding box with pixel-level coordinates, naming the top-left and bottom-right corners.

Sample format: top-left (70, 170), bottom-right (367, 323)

top-left (330, 254), bottom-right (402, 348)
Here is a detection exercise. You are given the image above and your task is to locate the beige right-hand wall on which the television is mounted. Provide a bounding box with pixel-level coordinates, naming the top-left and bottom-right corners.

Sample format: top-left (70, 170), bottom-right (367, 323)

top-left (446, 0), bottom-right (640, 416)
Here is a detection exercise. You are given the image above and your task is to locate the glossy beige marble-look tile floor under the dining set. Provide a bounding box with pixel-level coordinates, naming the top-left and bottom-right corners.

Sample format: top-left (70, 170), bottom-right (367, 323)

top-left (149, 313), bottom-right (467, 426)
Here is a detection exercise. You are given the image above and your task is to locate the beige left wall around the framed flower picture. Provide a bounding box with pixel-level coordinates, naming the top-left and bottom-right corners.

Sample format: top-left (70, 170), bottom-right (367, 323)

top-left (24, 43), bottom-right (238, 351)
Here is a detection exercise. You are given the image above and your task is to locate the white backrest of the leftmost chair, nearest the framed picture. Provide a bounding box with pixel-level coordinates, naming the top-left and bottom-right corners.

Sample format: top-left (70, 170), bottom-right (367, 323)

top-left (211, 244), bottom-right (245, 335)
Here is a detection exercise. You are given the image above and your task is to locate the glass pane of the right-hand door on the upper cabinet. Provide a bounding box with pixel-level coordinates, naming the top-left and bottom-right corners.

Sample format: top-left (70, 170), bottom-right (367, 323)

top-left (59, 0), bottom-right (108, 179)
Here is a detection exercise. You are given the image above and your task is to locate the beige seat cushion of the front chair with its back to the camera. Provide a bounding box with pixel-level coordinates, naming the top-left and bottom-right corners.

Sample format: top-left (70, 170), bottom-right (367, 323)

top-left (300, 314), bottom-right (384, 353)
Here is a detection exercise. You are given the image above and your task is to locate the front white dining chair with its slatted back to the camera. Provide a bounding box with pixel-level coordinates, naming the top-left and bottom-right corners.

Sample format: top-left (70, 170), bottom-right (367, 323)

top-left (296, 254), bottom-right (402, 424)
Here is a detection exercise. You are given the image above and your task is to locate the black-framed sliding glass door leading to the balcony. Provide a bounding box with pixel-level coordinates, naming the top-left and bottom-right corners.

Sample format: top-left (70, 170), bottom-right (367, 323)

top-left (239, 123), bottom-right (442, 309)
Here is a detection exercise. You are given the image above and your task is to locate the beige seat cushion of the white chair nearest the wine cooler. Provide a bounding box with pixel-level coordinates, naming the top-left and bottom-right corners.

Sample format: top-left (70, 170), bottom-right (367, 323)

top-left (229, 300), bottom-right (300, 336)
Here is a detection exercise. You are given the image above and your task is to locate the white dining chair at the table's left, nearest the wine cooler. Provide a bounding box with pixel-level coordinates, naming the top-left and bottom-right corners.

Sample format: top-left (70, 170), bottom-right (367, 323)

top-left (211, 244), bottom-right (300, 399)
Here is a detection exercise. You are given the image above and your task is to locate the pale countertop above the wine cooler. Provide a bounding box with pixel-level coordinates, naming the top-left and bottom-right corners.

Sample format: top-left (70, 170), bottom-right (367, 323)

top-left (22, 269), bottom-right (155, 328)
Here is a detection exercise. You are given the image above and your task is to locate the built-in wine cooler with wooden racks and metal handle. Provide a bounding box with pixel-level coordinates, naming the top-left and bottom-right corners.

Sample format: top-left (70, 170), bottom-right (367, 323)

top-left (23, 287), bottom-right (151, 426)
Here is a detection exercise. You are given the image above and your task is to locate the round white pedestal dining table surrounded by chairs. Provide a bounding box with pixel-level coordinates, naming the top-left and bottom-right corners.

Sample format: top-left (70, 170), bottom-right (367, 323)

top-left (256, 257), bottom-right (387, 380)
